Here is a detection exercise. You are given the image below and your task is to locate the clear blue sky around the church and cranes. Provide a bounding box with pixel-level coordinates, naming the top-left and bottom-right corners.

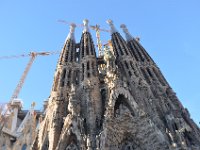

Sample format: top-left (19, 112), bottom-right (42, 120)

top-left (0, 0), bottom-right (200, 125)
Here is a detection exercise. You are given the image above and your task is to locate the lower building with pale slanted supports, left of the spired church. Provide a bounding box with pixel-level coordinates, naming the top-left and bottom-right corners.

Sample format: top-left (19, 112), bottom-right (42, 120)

top-left (0, 99), bottom-right (42, 150)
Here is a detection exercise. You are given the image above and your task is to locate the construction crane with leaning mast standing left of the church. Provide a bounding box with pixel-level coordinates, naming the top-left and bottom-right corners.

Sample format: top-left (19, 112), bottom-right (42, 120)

top-left (0, 51), bottom-right (60, 128)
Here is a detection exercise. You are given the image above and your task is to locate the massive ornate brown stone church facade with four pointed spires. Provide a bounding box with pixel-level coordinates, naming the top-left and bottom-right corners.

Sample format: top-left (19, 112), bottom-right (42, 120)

top-left (32, 19), bottom-right (200, 150)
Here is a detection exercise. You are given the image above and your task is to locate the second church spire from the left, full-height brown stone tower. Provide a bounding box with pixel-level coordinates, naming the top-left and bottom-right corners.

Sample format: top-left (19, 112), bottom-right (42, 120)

top-left (80, 19), bottom-right (102, 144)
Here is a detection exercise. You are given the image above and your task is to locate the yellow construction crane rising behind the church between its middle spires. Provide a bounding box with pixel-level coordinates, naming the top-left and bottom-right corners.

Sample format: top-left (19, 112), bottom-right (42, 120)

top-left (58, 20), bottom-right (110, 57)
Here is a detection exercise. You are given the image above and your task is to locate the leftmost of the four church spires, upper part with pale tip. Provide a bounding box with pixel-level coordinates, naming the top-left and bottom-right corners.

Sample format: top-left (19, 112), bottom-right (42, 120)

top-left (52, 23), bottom-right (78, 91)
